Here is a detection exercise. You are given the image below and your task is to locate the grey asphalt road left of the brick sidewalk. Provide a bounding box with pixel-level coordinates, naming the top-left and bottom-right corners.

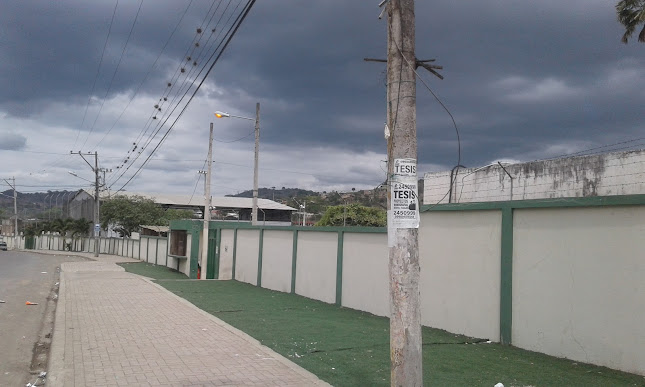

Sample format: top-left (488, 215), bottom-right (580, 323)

top-left (0, 251), bottom-right (86, 386)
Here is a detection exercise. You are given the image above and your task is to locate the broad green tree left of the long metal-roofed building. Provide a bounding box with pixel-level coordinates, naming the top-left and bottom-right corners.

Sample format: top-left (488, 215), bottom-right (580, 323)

top-left (101, 195), bottom-right (193, 238)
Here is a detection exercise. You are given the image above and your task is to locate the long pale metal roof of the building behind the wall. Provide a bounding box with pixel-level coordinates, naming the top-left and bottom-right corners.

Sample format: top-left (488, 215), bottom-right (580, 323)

top-left (102, 192), bottom-right (296, 211)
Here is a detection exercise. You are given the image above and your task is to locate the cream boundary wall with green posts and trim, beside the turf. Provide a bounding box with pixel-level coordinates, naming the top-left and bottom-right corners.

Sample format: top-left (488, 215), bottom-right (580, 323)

top-left (171, 195), bottom-right (645, 375)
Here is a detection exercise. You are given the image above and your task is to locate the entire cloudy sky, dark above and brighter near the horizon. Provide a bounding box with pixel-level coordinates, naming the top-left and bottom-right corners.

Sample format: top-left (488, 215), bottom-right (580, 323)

top-left (0, 0), bottom-right (645, 199)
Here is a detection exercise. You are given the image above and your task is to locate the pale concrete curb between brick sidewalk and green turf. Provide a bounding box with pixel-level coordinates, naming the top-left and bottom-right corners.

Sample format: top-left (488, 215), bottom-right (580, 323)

top-left (143, 274), bottom-right (331, 386)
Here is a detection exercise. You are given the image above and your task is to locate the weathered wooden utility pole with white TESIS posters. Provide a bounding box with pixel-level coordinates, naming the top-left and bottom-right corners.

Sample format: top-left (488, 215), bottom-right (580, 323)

top-left (386, 0), bottom-right (423, 386)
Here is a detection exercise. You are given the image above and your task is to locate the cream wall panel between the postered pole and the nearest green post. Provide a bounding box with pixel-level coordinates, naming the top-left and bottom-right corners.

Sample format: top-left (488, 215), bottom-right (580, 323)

top-left (419, 211), bottom-right (502, 341)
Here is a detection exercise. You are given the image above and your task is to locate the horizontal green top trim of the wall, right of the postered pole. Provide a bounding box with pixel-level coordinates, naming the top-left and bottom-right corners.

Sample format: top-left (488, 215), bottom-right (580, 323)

top-left (421, 194), bottom-right (645, 212)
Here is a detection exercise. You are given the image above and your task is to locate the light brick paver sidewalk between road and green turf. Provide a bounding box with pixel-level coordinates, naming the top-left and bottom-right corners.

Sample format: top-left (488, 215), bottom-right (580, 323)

top-left (47, 262), bottom-right (327, 386)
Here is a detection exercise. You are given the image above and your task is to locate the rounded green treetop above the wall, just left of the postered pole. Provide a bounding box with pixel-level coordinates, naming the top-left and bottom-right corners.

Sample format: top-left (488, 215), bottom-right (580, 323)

top-left (316, 204), bottom-right (387, 227)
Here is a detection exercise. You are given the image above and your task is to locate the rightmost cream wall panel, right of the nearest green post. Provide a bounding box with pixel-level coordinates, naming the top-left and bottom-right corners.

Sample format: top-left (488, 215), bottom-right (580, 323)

top-left (512, 206), bottom-right (645, 374)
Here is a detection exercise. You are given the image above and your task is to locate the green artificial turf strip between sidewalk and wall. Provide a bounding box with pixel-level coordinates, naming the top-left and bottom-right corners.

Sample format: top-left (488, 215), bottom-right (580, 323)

top-left (147, 280), bottom-right (645, 387)
